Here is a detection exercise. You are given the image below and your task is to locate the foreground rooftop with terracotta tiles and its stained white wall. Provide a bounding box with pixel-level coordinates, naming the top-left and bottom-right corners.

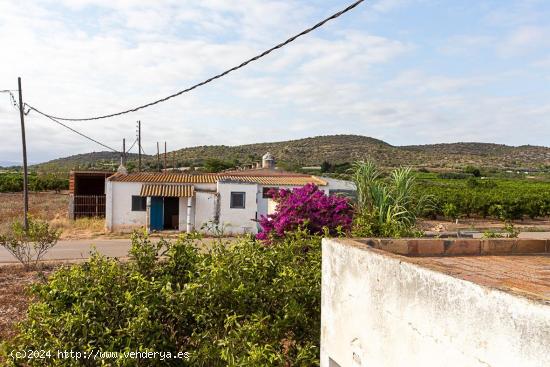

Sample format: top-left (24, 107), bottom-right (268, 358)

top-left (321, 239), bottom-right (550, 367)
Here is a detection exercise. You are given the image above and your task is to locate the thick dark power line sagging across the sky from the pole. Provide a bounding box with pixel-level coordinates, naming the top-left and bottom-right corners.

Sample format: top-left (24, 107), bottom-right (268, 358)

top-left (25, 0), bottom-right (364, 121)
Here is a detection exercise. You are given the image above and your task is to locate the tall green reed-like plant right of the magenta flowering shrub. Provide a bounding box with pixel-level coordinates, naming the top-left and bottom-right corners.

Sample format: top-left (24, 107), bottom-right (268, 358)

top-left (353, 161), bottom-right (430, 237)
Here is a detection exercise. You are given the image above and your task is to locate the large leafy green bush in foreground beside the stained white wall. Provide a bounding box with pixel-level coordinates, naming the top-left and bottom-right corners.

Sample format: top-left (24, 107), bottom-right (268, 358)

top-left (3, 231), bottom-right (321, 366)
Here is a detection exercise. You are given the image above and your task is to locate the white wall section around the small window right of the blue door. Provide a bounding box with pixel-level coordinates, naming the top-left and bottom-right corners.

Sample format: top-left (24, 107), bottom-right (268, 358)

top-left (218, 182), bottom-right (258, 234)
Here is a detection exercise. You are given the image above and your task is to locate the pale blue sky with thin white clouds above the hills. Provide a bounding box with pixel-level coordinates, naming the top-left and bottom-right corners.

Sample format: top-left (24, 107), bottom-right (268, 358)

top-left (0, 0), bottom-right (550, 162)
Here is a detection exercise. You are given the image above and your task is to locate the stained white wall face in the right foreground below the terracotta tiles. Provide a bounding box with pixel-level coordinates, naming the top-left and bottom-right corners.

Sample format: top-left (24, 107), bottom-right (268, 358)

top-left (321, 239), bottom-right (550, 367)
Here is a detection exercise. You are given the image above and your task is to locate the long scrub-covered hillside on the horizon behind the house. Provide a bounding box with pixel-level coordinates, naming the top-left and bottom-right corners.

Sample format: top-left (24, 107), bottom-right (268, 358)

top-left (30, 135), bottom-right (550, 171)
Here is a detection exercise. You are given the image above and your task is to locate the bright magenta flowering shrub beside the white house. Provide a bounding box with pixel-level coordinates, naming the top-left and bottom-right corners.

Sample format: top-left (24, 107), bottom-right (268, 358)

top-left (256, 184), bottom-right (353, 240)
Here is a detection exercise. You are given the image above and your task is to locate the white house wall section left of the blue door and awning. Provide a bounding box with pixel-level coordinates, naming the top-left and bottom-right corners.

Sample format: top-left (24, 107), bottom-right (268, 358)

top-left (110, 181), bottom-right (147, 231)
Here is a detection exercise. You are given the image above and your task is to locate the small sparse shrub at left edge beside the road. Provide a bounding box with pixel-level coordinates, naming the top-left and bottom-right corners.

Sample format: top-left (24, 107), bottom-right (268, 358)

top-left (0, 217), bottom-right (61, 269)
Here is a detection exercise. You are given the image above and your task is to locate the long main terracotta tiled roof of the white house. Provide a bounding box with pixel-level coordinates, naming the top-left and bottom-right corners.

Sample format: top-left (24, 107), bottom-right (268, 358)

top-left (108, 172), bottom-right (327, 186)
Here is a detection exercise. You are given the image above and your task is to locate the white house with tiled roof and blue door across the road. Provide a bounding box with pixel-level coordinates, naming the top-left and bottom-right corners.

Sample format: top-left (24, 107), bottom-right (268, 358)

top-left (105, 154), bottom-right (352, 234)
